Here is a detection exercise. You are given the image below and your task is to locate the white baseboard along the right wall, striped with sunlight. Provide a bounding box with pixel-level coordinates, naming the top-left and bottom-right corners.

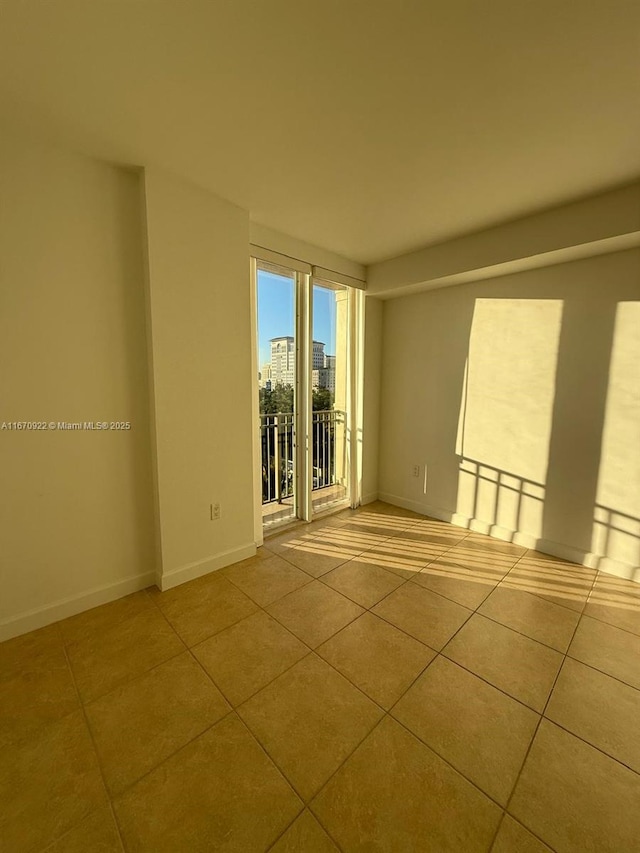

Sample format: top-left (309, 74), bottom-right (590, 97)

top-left (378, 492), bottom-right (640, 583)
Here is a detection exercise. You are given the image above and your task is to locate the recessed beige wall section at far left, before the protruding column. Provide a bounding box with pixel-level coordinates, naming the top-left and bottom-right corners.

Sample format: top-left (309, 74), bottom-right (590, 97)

top-left (0, 125), bottom-right (154, 638)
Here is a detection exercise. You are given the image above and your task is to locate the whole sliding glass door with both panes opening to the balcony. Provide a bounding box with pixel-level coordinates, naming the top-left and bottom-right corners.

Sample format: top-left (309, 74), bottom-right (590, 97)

top-left (255, 261), bottom-right (351, 529)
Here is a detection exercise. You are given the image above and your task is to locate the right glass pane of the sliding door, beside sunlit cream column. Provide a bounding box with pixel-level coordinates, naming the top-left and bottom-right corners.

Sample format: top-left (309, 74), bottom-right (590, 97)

top-left (311, 282), bottom-right (349, 512)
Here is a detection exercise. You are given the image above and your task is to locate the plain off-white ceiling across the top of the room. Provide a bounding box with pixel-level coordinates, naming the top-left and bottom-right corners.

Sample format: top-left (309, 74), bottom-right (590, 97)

top-left (0, 0), bottom-right (640, 263)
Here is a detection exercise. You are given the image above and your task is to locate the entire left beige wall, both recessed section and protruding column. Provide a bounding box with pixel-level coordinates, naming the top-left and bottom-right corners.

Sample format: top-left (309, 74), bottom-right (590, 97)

top-left (0, 132), bottom-right (255, 639)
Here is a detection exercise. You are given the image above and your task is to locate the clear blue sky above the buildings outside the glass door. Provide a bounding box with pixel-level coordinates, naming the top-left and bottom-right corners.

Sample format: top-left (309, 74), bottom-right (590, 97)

top-left (258, 270), bottom-right (336, 366)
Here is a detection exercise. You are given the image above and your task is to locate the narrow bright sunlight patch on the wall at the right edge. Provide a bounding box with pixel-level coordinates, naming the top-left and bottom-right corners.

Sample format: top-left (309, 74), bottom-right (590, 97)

top-left (592, 302), bottom-right (640, 569)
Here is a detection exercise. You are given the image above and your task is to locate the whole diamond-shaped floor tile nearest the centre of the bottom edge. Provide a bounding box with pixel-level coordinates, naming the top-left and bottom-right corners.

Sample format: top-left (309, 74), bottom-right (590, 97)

top-left (238, 655), bottom-right (382, 800)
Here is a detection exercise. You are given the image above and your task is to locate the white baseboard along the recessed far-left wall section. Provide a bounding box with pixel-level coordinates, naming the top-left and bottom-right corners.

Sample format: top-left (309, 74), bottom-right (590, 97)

top-left (0, 572), bottom-right (156, 642)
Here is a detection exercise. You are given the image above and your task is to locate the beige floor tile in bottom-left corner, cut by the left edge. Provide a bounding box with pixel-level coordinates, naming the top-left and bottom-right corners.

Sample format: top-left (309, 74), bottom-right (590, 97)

top-left (0, 711), bottom-right (107, 853)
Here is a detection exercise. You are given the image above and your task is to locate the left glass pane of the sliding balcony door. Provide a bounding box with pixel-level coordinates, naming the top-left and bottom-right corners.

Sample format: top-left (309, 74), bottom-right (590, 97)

top-left (257, 268), bottom-right (296, 526)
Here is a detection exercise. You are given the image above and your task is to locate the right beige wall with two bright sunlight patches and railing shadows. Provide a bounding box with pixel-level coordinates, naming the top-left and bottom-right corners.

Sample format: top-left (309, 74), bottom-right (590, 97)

top-left (379, 249), bottom-right (640, 577)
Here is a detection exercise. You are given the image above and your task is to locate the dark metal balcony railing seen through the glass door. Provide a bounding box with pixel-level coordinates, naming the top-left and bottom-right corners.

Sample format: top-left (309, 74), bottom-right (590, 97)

top-left (260, 410), bottom-right (345, 504)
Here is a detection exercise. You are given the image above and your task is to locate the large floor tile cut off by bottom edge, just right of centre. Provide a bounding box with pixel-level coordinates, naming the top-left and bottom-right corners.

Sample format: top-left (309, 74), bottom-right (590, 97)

top-left (311, 717), bottom-right (501, 853)
